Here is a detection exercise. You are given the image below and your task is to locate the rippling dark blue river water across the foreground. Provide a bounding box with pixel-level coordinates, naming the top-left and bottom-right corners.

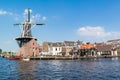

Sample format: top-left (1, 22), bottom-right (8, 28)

top-left (0, 57), bottom-right (120, 80)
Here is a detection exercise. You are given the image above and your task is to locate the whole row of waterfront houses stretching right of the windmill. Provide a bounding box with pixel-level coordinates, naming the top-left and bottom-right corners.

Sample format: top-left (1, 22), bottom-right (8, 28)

top-left (41, 41), bottom-right (120, 57)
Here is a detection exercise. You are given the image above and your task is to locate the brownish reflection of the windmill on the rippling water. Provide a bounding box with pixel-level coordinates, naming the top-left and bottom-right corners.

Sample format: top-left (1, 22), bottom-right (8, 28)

top-left (18, 61), bottom-right (37, 80)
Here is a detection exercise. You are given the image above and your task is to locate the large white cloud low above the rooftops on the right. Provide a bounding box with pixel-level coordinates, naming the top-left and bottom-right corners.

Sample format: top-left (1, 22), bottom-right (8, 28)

top-left (77, 26), bottom-right (120, 39)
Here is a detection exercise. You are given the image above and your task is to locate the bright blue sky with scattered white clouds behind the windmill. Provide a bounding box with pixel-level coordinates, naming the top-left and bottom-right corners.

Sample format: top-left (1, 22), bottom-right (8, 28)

top-left (0, 0), bottom-right (120, 51)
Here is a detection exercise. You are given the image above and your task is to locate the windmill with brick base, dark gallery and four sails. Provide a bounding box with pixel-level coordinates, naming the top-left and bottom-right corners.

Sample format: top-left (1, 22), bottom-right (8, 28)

top-left (14, 8), bottom-right (44, 58)
